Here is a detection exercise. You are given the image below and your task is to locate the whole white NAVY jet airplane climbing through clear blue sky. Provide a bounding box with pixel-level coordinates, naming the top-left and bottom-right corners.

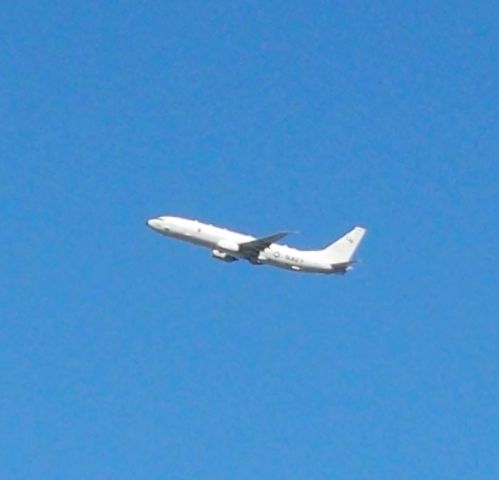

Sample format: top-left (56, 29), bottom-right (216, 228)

top-left (146, 216), bottom-right (366, 274)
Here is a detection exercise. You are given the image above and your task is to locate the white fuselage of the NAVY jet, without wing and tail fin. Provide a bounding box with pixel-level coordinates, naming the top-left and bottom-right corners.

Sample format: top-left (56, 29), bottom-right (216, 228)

top-left (147, 216), bottom-right (344, 273)
